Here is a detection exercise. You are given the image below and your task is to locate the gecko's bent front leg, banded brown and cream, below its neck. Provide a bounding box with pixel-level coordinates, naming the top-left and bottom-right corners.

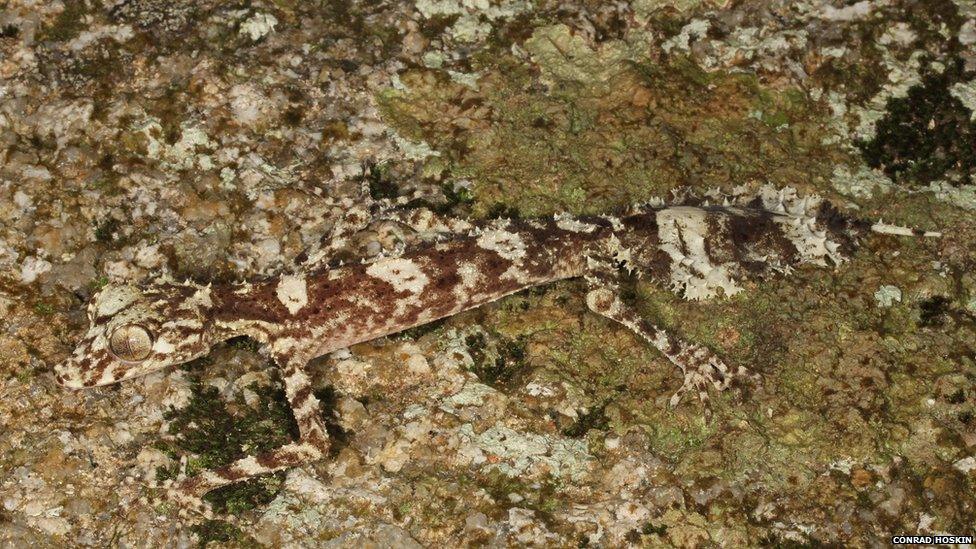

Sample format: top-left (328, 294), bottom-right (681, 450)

top-left (167, 361), bottom-right (329, 518)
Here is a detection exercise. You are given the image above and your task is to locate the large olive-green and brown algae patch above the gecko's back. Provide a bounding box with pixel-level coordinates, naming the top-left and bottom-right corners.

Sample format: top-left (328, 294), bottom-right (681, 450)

top-left (379, 25), bottom-right (849, 216)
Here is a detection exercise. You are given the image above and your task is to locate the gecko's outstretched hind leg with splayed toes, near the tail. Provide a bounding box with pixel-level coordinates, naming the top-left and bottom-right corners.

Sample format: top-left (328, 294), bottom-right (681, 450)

top-left (586, 276), bottom-right (758, 418)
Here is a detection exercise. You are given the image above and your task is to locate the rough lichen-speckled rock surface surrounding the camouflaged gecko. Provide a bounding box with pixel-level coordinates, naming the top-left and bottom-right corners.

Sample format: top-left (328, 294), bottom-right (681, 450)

top-left (0, 0), bottom-right (976, 547)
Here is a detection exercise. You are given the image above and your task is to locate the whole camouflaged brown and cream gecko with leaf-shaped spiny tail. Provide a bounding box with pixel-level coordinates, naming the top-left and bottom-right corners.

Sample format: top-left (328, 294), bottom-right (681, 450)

top-left (57, 186), bottom-right (938, 512)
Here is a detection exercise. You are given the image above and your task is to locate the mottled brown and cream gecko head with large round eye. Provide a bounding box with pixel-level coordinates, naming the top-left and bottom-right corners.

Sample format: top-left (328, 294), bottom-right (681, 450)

top-left (55, 281), bottom-right (214, 389)
